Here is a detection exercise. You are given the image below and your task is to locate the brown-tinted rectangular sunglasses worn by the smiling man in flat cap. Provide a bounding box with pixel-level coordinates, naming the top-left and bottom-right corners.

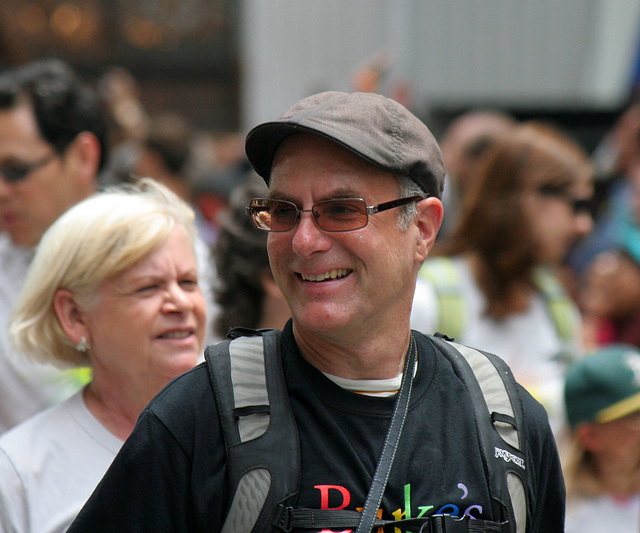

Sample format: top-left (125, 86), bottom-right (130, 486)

top-left (246, 196), bottom-right (426, 232)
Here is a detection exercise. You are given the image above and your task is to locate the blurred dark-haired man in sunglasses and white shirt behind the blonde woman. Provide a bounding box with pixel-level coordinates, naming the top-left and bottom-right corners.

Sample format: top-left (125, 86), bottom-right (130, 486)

top-left (0, 59), bottom-right (107, 433)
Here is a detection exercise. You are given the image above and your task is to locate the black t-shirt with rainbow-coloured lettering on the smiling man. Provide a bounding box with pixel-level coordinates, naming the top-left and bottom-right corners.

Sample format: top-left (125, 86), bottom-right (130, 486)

top-left (69, 327), bottom-right (564, 533)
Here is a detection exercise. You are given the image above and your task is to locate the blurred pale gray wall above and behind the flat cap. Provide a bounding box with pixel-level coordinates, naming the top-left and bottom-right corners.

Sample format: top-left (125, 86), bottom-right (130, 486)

top-left (241, 0), bottom-right (640, 129)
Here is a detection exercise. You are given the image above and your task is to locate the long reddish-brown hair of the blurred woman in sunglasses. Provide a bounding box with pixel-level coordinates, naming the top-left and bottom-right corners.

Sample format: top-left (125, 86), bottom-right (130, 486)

top-left (441, 122), bottom-right (593, 318)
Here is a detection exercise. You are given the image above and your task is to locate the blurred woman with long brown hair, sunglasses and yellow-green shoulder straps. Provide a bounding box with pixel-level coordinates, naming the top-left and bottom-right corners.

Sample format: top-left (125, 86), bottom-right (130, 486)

top-left (412, 122), bottom-right (593, 431)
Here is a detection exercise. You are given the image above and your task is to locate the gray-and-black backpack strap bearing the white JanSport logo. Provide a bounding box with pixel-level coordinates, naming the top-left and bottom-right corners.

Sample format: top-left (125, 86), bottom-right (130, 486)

top-left (430, 337), bottom-right (527, 533)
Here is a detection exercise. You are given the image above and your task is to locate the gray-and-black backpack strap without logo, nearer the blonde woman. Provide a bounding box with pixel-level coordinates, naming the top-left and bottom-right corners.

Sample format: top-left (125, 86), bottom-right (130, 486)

top-left (205, 330), bottom-right (300, 533)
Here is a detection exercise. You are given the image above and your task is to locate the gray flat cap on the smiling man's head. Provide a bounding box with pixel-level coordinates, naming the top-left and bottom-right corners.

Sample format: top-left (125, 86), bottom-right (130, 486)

top-left (245, 91), bottom-right (445, 198)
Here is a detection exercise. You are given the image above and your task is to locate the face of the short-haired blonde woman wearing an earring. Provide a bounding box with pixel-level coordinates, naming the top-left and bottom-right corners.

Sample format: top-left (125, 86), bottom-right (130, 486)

top-left (81, 228), bottom-right (206, 394)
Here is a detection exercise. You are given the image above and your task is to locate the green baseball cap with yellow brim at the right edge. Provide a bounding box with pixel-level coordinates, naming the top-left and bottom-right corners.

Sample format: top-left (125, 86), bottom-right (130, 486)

top-left (564, 344), bottom-right (640, 429)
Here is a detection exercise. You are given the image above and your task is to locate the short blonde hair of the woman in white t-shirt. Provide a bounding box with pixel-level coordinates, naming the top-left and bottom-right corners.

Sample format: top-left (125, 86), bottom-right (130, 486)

top-left (9, 178), bottom-right (195, 365)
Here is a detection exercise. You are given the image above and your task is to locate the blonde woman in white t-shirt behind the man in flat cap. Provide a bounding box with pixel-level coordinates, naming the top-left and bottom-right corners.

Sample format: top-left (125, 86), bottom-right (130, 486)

top-left (0, 179), bottom-right (206, 533)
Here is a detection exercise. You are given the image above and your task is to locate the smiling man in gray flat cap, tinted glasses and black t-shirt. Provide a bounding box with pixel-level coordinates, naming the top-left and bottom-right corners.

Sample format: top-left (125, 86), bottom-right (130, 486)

top-left (69, 92), bottom-right (564, 533)
